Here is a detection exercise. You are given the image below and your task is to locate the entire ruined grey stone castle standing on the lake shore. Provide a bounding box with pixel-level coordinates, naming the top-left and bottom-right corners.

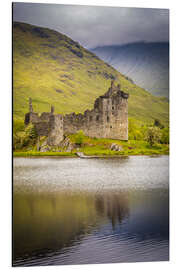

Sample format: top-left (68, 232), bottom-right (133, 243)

top-left (25, 81), bottom-right (129, 146)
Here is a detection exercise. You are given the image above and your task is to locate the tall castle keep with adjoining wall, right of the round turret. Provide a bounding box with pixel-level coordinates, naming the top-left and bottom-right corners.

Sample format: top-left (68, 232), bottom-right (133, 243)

top-left (64, 81), bottom-right (128, 140)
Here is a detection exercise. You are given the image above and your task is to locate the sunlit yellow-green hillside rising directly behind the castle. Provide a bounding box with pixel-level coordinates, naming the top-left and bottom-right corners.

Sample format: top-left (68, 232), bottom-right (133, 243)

top-left (13, 22), bottom-right (169, 124)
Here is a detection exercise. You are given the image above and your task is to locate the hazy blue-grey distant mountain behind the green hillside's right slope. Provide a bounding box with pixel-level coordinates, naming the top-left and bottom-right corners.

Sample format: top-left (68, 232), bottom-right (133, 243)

top-left (91, 42), bottom-right (169, 97)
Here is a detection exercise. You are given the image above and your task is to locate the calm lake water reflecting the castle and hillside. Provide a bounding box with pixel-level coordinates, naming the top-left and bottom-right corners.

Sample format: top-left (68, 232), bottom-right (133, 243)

top-left (13, 156), bottom-right (169, 266)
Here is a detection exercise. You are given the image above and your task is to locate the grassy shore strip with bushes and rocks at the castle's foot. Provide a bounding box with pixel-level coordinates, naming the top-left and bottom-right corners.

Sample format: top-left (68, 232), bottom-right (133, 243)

top-left (14, 121), bottom-right (169, 157)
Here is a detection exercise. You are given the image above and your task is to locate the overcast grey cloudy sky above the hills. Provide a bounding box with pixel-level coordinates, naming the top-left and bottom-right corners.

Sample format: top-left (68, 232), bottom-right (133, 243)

top-left (13, 3), bottom-right (169, 48)
